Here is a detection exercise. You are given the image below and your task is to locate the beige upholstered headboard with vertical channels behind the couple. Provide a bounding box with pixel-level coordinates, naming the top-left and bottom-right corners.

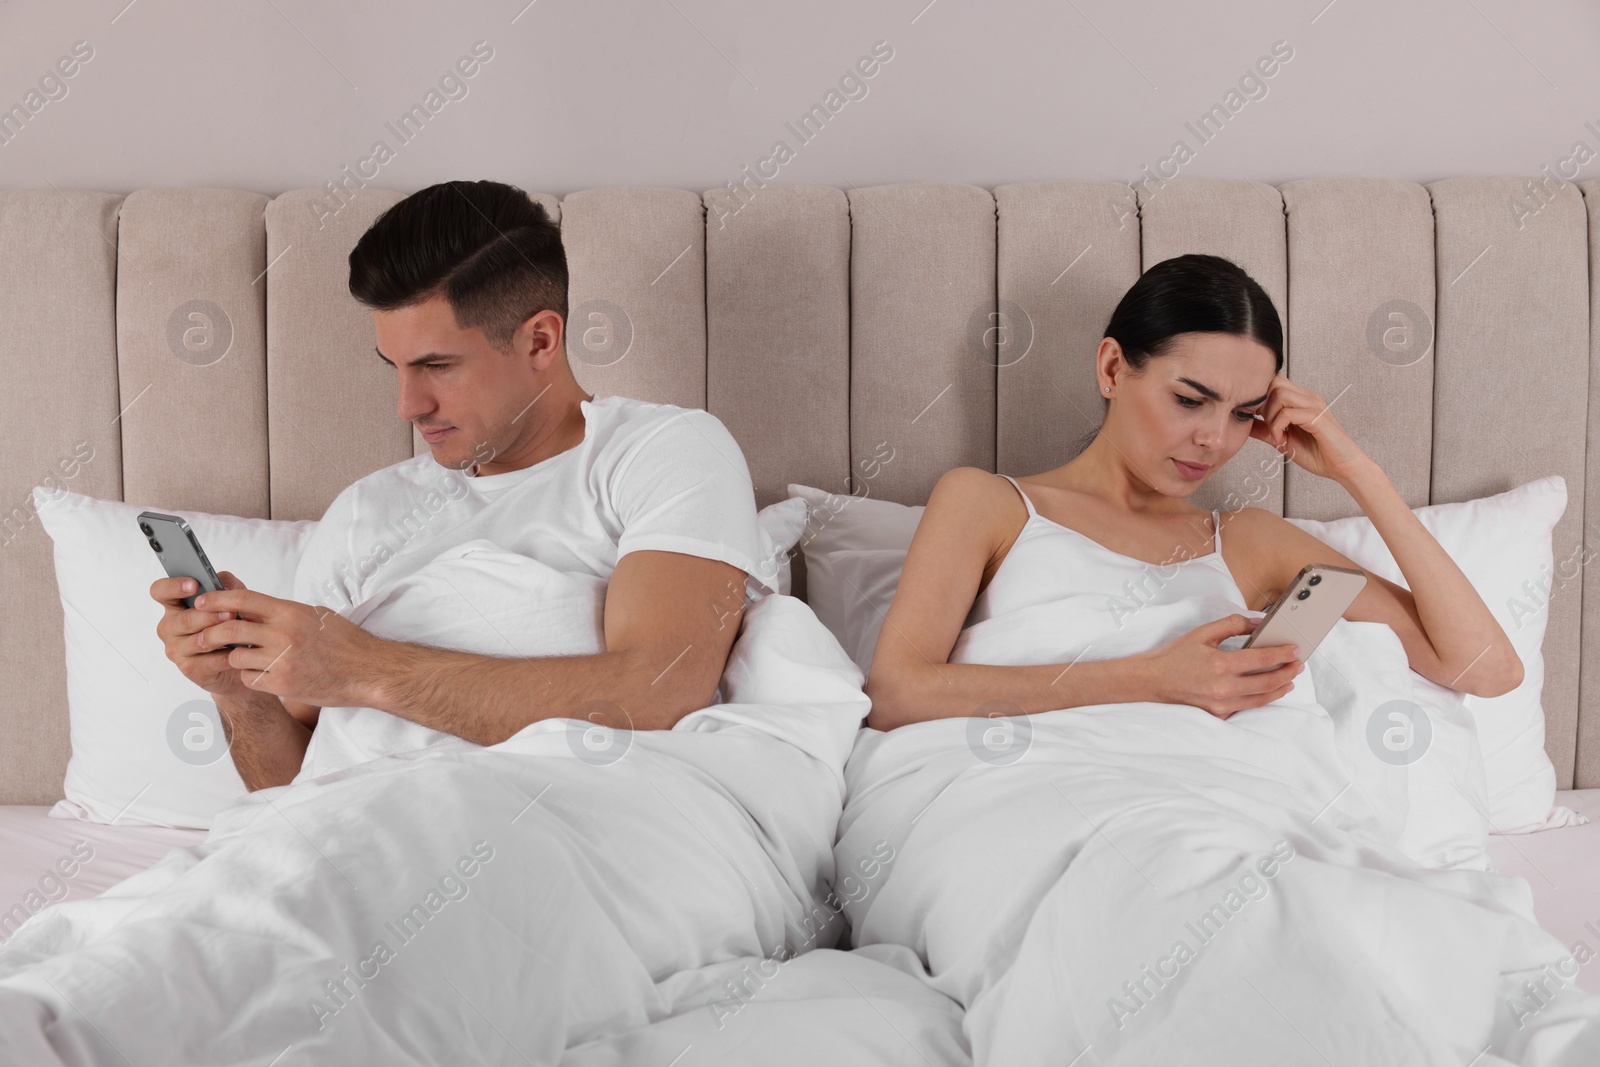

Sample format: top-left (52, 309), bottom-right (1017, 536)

top-left (0, 178), bottom-right (1600, 803)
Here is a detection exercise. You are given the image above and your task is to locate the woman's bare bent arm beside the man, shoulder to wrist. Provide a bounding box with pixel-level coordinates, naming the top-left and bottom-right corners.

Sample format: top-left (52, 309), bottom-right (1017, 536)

top-left (866, 467), bottom-right (1147, 729)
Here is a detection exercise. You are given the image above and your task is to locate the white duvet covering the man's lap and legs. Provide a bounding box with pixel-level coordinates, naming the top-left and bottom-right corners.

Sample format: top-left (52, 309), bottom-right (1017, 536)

top-left (0, 545), bottom-right (867, 1067)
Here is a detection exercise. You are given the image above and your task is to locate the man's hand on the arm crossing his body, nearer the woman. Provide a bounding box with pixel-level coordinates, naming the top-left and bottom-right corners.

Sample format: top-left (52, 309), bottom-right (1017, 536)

top-left (184, 581), bottom-right (382, 707)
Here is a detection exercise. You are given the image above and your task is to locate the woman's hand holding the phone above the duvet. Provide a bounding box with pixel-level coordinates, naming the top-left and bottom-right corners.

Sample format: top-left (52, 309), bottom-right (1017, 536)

top-left (1133, 614), bottom-right (1306, 718)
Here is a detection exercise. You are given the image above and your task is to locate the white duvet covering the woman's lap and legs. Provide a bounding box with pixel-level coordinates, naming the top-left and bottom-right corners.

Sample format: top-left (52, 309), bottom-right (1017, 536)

top-left (835, 605), bottom-right (1600, 1067)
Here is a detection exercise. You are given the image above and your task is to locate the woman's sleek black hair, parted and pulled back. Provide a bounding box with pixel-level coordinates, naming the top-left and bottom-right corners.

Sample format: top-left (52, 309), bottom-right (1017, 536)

top-left (1074, 253), bottom-right (1283, 456)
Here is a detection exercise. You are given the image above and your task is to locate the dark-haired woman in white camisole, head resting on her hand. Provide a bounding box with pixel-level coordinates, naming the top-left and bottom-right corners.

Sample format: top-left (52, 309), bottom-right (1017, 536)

top-left (867, 256), bottom-right (1522, 729)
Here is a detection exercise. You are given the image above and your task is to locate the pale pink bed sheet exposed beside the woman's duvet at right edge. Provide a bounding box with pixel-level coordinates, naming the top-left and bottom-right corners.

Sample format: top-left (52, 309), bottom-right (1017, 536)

top-left (1488, 789), bottom-right (1600, 993)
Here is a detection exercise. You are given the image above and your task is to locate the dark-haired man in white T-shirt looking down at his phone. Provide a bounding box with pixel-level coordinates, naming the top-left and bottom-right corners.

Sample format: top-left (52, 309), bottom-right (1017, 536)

top-left (150, 181), bottom-right (762, 790)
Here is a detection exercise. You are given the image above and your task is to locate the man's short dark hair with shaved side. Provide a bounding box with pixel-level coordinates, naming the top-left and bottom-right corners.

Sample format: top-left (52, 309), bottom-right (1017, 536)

top-left (350, 181), bottom-right (566, 349)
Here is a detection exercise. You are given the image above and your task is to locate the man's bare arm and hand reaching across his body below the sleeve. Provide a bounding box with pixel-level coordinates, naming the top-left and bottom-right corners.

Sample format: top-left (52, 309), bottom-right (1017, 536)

top-left (197, 550), bottom-right (746, 748)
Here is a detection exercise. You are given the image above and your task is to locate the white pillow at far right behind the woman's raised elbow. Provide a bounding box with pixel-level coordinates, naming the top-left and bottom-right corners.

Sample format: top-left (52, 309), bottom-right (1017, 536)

top-left (1290, 475), bottom-right (1581, 833)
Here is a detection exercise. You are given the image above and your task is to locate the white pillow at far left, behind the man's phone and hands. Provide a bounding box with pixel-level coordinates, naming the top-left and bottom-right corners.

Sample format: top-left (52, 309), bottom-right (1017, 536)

top-left (34, 486), bottom-right (317, 829)
